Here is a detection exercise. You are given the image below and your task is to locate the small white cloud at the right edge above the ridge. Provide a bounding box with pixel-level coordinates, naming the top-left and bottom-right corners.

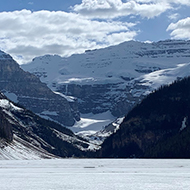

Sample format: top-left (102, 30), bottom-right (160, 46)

top-left (167, 17), bottom-right (190, 39)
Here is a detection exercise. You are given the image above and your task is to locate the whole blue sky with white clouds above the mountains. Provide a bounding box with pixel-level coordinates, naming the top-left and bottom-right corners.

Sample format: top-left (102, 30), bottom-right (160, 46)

top-left (0, 0), bottom-right (190, 64)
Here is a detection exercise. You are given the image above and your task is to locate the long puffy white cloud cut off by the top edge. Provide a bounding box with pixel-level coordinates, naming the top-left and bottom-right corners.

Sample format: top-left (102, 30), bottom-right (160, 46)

top-left (73, 0), bottom-right (171, 18)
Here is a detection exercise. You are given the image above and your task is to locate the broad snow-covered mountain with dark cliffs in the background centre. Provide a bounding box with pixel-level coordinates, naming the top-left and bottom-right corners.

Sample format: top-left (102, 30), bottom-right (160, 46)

top-left (21, 40), bottom-right (190, 138)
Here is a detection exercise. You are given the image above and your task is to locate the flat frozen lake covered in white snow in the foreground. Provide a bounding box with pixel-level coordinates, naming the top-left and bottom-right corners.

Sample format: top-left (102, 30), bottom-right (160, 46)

top-left (0, 159), bottom-right (190, 190)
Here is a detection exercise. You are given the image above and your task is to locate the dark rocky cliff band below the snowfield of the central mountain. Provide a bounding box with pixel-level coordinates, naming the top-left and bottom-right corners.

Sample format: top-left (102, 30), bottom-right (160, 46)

top-left (57, 83), bottom-right (135, 117)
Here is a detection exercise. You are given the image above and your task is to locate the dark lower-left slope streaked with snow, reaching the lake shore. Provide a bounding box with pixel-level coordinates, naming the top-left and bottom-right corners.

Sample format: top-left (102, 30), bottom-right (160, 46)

top-left (0, 94), bottom-right (90, 159)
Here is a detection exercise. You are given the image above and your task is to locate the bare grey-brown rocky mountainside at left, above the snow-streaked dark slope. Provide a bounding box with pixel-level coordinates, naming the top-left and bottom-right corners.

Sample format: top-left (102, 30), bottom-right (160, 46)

top-left (0, 51), bottom-right (80, 126)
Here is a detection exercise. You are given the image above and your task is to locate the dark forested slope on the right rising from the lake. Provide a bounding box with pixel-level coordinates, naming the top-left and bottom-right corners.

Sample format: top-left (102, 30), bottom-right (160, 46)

top-left (99, 77), bottom-right (190, 158)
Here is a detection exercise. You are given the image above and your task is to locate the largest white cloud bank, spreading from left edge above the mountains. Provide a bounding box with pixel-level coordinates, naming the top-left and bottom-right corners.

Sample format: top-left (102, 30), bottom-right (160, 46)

top-left (0, 10), bottom-right (137, 63)
